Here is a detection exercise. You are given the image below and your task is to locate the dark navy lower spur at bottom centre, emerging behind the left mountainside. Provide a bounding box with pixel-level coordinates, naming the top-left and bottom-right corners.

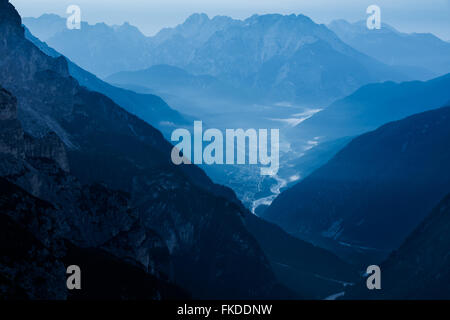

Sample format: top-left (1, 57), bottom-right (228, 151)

top-left (245, 214), bottom-right (358, 299)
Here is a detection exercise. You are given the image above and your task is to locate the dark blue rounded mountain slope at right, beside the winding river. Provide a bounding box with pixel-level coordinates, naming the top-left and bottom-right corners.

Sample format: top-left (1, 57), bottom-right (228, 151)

top-left (264, 107), bottom-right (450, 260)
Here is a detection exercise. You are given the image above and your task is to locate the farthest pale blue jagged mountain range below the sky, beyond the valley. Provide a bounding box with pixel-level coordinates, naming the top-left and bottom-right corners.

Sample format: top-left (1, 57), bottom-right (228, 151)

top-left (24, 14), bottom-right (409, 103)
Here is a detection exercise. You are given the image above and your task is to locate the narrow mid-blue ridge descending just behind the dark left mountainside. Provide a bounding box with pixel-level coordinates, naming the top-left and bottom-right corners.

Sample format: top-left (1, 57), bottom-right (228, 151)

top-left (25, 29), bottom-right (188, 137)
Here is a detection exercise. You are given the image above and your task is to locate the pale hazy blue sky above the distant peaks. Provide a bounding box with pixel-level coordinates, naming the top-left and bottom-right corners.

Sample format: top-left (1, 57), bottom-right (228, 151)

top-left (11, 0), bottom-right (450, 40)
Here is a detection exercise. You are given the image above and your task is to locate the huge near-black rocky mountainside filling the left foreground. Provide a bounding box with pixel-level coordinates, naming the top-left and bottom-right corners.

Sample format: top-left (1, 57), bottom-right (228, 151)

top-left (0, 0), bottom-right (355, 299)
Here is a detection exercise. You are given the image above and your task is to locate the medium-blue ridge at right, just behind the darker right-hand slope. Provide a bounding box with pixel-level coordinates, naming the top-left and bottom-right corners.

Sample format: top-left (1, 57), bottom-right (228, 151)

top-left (288, 74), bottom-right (450, 196)
